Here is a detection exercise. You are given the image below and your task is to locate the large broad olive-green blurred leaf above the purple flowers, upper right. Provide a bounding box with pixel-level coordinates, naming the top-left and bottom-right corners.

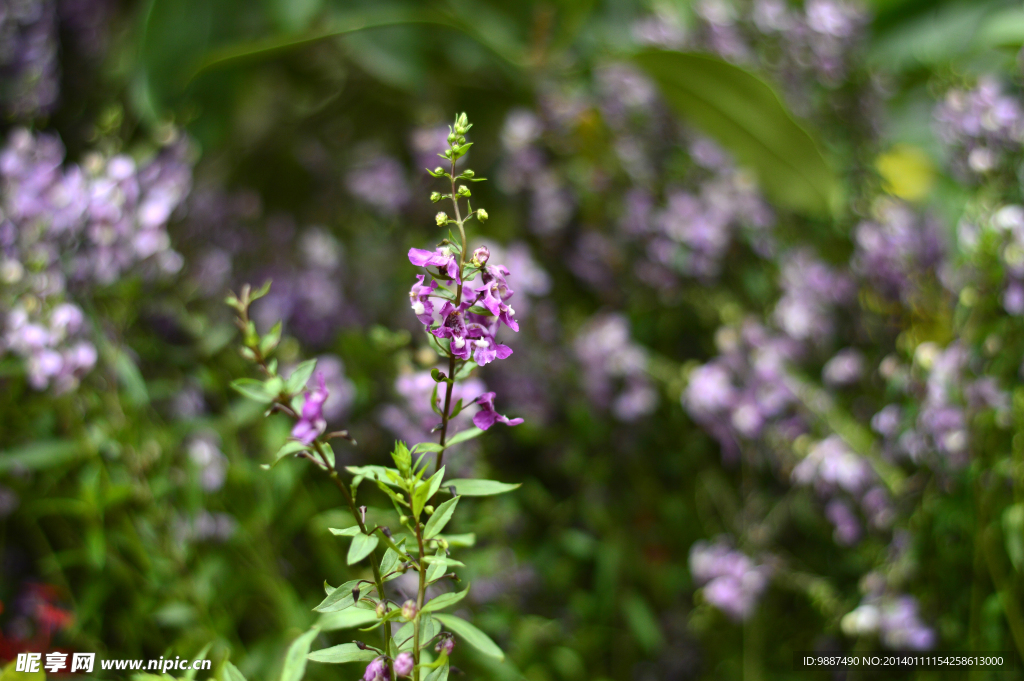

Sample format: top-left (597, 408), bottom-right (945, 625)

top-left (634, 49), bottom-right (840, 216)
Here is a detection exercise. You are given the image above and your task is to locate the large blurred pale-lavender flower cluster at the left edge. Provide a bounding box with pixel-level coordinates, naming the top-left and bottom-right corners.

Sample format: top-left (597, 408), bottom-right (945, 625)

top-left (0, 129), bottom-right (191, 391)
